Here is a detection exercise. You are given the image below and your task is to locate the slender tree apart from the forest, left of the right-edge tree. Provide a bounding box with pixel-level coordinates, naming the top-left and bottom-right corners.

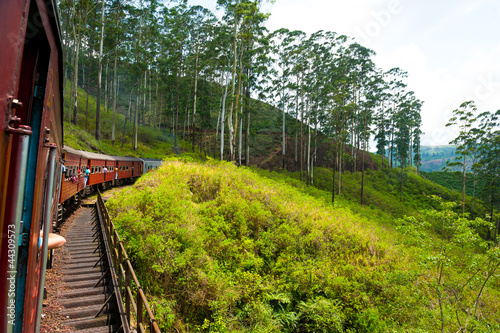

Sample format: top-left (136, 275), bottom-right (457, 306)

top-left (446, 101), bottom-right (478, 215)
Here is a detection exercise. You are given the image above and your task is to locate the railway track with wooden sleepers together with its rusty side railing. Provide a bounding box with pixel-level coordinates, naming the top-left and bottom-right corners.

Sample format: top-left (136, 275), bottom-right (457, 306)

top-left (42, 192), bottom-right (160, 333)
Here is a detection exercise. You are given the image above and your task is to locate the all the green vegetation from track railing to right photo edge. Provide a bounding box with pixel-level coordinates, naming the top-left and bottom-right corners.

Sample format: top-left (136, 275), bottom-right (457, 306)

top-left (108, 158), bottom-right (500, 332)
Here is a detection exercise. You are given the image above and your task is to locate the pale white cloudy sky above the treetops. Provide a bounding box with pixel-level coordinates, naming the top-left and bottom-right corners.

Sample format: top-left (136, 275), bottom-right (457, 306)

top-left (185, 0), bottom-right (500, 146)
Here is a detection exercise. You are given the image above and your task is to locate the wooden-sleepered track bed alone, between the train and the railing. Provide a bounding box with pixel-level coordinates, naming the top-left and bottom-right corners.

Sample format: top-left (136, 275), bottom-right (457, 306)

top-left (49, 207), bottom-right (123, 333)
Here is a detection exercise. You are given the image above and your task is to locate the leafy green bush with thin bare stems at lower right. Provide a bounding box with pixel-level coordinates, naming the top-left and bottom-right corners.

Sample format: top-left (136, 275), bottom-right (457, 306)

top-left (399, 197), bottom-right (500, 332)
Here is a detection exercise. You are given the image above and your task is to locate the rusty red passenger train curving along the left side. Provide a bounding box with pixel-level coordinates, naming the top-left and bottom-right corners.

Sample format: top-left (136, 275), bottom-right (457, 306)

top-left (0, 0), bottom-right (160, 333)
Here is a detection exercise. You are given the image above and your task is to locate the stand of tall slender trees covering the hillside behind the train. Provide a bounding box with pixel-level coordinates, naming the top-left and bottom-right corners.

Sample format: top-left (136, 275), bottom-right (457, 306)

top-left (59, 0), bottom-right (422, 183)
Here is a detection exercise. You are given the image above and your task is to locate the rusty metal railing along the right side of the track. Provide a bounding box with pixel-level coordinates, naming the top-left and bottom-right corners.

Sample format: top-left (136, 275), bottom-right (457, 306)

top-left (97, 191), bottom-right (161, 333)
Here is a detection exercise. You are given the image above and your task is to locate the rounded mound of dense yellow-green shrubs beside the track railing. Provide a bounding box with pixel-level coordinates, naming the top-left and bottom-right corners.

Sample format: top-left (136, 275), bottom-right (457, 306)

top-left (108, 160), bottom-right (500, 332)
